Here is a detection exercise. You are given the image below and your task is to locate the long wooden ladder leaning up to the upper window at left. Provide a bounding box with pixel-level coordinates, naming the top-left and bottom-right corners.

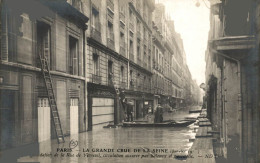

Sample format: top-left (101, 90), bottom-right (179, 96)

top-left (39, 55), bottom-right (65, 144)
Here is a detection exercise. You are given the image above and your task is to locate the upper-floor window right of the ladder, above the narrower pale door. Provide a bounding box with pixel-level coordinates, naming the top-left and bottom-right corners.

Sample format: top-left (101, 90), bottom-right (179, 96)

top-left (69, 36), bottom-right (79, 75)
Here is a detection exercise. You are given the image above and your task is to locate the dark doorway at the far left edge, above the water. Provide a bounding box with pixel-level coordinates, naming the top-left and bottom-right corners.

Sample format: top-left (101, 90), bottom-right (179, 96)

top-left (0, 90), bottom-right (15, 149)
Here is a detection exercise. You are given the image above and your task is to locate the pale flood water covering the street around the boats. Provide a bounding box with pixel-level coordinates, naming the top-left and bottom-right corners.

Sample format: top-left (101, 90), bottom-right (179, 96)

top-left (15, 107), bottom-right (199, 163)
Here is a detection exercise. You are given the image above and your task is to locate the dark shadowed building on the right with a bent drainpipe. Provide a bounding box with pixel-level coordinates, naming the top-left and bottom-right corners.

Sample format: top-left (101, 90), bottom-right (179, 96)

top-left (205, 0), bottom-right (259, 162)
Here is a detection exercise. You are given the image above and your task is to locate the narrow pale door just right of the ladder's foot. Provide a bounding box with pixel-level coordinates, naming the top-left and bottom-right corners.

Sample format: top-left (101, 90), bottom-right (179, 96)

top-left (70, 98), bottom-right (79, 135)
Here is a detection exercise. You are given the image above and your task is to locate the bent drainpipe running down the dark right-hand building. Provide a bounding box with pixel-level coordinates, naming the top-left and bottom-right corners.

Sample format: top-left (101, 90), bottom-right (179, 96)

top-left (211, 49), bottom-right (243, 155)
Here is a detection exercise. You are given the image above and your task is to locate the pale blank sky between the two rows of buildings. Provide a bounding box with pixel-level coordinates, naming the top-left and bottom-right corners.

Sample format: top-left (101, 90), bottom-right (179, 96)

top-left (159, 0), bottom-right (210, 84)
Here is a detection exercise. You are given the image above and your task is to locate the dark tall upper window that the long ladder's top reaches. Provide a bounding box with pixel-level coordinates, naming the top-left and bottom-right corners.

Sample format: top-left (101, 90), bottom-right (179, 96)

top-left (36, 22), bottom-right (52, 69)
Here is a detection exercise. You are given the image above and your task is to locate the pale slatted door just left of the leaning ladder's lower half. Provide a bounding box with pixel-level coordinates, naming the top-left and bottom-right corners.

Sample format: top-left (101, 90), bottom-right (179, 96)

top-left (38, 98), bottom-right (51, 142)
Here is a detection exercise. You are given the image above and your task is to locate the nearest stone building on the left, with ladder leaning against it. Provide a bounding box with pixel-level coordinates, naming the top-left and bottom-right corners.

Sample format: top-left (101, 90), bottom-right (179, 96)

top-left (0, 0), bottom-right (88, 149)
